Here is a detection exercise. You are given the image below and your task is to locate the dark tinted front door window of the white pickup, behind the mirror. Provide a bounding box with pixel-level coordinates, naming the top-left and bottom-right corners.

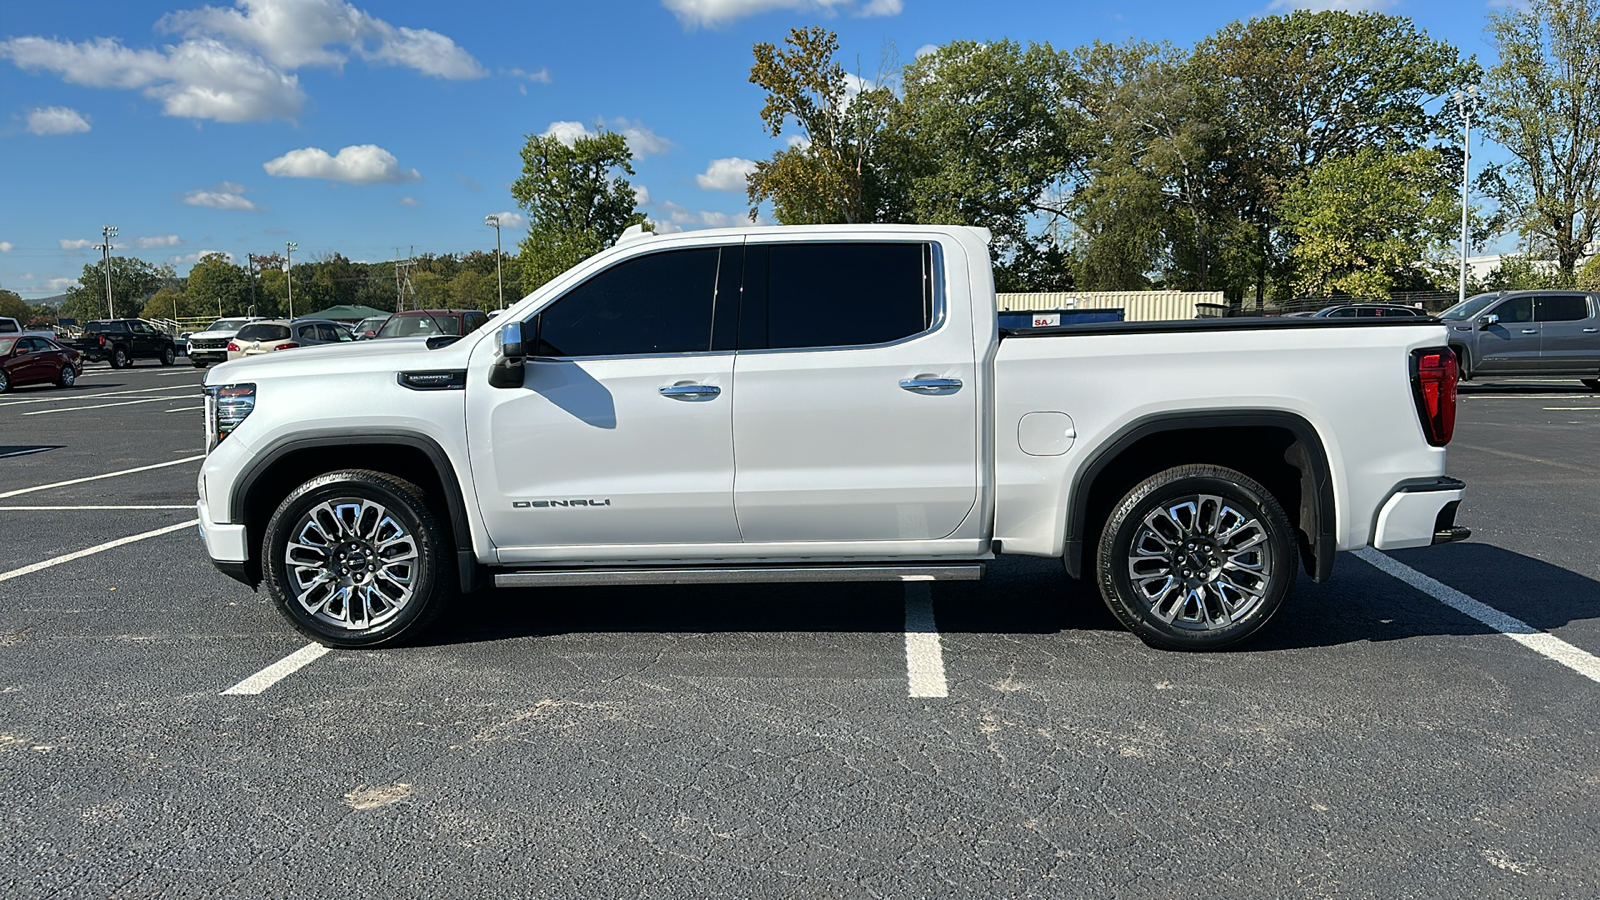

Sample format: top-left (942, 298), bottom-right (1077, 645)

top-left (534, 247), bottom-right (720, 357)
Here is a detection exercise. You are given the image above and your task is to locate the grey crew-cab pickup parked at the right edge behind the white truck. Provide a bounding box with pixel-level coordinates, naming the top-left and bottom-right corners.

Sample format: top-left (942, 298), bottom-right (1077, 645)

top-left (1438, 290), bottom-right (1600, 391)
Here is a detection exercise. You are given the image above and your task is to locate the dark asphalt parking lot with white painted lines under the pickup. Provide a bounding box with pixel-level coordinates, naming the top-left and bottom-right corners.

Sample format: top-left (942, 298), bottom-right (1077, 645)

top-left (0, 362), bottom-right (1600, 897)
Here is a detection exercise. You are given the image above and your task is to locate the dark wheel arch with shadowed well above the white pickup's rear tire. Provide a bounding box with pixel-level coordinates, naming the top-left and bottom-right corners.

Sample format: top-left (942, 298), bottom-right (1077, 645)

top-left (1062, 410), bottom-right (1338, 581)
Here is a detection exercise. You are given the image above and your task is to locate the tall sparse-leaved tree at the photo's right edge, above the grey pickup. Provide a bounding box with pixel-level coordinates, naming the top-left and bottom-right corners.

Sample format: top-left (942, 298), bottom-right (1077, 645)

top-left (1483, 0), bottom-right (1600, 277)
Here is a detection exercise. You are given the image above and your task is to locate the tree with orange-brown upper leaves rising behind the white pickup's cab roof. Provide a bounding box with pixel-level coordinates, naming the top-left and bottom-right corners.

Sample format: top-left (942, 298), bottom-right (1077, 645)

top-left (747, 27), bottom-right (907, 224)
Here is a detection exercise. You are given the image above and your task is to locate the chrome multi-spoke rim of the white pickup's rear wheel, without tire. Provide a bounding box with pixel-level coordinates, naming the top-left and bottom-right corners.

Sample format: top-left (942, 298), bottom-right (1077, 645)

top-left (1128, 495), bottom-right (1272, 631)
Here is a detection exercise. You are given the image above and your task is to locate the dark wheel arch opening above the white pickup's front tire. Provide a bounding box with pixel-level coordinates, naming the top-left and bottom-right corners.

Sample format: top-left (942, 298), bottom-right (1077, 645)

top-left (229, 431), bottom-right (480, 593)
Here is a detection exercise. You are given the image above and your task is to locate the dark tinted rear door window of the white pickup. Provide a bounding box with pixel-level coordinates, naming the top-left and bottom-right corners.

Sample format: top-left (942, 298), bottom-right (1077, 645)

top-left (766, 242), bottom-right (933, 349)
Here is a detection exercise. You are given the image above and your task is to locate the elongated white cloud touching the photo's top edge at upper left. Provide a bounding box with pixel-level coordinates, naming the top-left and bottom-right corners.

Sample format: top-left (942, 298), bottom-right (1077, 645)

top-left (158, 0), bottom-right (488, 78)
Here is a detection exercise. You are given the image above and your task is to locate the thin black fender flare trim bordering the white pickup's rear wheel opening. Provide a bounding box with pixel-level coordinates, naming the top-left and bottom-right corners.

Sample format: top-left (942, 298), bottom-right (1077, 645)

top-left (1062, 410), bottom-right (1338, 581)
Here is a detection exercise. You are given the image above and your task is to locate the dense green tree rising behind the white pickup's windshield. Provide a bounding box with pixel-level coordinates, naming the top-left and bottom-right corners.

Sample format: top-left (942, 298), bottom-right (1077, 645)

top-left (510, 128), bottom-right (648, 291)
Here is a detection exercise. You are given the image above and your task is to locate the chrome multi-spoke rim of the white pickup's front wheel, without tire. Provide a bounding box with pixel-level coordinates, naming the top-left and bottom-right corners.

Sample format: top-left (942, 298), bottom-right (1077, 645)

top-left (283, 498), bottom-right (418, 631)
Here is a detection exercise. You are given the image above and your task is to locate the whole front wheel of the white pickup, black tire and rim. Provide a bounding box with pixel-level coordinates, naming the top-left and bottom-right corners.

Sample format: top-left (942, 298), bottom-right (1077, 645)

top-left (261, 469), bottom-right (459, 647)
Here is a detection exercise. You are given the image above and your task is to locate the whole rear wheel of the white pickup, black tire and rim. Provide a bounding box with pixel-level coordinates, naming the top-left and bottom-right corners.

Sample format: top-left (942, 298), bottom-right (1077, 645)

top-left (1094, 466), bottom-right (1299, 650)
